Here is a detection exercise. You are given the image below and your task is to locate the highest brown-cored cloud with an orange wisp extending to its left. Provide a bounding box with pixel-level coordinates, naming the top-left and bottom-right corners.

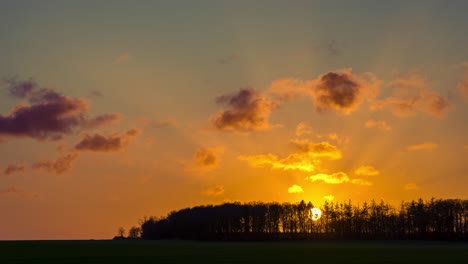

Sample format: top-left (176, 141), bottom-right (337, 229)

top-left (268, 68), bottom-right (381, 114)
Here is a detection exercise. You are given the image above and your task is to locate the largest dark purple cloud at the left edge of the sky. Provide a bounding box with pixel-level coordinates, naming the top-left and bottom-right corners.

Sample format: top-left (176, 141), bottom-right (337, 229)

top-left (0, 80), bottom-right (120, 140)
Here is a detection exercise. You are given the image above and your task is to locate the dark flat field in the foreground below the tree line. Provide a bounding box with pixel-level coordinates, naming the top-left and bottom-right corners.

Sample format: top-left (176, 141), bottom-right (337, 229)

top-left (0, 241), bottom-right (468, 264)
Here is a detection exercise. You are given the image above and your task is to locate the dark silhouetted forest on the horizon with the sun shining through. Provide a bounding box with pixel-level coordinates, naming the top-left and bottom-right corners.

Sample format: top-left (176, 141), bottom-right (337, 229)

top-left (131, 198), bottom-right (468, 241)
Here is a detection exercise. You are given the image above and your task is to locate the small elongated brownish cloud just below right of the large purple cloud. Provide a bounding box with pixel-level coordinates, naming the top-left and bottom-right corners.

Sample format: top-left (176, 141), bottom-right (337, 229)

top-left (75, 129), bottom-right (138, 152)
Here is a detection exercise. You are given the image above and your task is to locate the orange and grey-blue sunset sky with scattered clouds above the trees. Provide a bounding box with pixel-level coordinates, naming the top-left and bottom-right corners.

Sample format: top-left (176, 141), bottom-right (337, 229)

top-left (0, 0), bottom-right (468, 240)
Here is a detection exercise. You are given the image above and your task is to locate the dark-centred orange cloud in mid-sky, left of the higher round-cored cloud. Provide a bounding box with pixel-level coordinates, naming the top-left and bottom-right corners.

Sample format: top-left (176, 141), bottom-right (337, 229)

top-left (211, 89), bottom-right (276, 133)
